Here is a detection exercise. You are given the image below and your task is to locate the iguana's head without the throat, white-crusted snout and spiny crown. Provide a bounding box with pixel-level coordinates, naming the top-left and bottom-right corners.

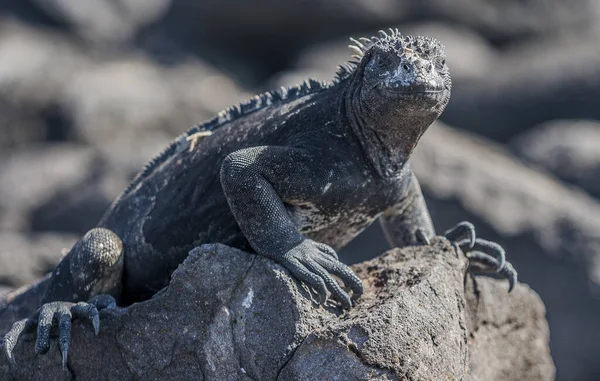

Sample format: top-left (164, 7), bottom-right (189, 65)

top-left (350, 29), bottom-right (452, 117)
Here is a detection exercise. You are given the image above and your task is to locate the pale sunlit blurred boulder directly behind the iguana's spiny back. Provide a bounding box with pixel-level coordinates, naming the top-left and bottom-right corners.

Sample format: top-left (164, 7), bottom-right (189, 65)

top-left (60, 53), bottom-right (248, 151)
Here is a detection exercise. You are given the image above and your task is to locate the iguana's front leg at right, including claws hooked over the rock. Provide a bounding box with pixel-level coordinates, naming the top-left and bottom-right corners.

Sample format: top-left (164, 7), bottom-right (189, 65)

top-left (380, 175), bottom-right (517, 292)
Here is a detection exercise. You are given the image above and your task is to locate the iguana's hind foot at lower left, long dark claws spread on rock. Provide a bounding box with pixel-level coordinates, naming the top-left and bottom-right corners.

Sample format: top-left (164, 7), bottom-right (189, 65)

top-left (4, 295), bottom-right (116, 369)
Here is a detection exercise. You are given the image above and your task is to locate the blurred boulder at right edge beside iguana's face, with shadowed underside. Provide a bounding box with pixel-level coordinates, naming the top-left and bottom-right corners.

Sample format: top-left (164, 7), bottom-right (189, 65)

top-left (441, 28), bottom-right (600, 142)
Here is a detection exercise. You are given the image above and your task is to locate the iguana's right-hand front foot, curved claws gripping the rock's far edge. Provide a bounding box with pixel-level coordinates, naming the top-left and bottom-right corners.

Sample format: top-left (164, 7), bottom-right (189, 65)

top-left (444, 221), bottom-right (517, 292)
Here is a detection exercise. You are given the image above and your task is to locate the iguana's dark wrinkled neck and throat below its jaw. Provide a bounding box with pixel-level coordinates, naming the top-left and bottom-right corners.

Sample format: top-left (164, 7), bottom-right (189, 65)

top-left (343, 78), bottom-right (435, 178)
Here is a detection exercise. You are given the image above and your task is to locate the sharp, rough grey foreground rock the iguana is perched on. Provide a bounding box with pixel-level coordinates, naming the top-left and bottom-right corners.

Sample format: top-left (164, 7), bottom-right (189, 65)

top-left (0, 238), bottom-right (554, 380)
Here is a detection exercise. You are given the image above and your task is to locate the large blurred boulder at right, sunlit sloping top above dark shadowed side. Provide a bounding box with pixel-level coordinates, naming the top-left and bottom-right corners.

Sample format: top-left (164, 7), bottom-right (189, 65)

top-left (412, 123), bottom-right (600, 380)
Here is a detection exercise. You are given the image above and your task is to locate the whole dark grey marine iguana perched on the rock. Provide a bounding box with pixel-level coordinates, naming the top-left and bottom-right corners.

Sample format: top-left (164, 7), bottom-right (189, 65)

top-left (4, 30), bottom-right (516, 366)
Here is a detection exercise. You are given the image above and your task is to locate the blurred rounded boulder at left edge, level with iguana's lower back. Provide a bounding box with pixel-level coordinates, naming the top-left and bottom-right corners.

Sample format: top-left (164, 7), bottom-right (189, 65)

top-left (0, 143), bottom-right (113, 233)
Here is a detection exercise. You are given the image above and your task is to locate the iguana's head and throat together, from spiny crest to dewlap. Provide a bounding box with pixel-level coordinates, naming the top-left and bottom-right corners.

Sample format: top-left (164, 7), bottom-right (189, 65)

top-left (337, 30), bottom-right (452, 176)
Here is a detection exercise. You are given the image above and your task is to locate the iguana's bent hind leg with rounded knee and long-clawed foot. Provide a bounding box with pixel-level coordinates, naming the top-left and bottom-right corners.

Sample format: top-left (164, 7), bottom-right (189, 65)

top-left (4, 228), bottom-right (123, 368)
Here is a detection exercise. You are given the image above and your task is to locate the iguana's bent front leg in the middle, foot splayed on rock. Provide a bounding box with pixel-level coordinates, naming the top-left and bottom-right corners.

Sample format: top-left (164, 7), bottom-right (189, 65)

top-left (221, 146), bottom-right (363, 308)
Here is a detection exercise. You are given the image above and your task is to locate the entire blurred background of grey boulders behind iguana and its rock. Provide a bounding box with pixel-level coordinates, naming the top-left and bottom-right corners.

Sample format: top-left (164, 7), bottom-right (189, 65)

top-left (0, 0), bottom-right (600, 380)
